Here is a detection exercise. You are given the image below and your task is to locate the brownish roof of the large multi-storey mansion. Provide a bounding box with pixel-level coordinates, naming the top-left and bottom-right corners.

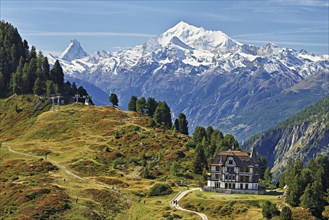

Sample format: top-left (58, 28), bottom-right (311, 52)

top-left (211, 150), bottom-right (258, 167)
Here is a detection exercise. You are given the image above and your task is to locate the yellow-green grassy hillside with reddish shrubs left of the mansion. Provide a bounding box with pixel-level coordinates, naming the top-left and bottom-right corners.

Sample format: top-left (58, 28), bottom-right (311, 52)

top-left (0, 95), bottom-right (200, 219)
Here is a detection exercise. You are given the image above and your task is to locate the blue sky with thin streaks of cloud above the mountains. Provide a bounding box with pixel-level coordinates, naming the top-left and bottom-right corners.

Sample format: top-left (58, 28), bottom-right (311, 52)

top-left (0, 0), bottom-right (329, 54)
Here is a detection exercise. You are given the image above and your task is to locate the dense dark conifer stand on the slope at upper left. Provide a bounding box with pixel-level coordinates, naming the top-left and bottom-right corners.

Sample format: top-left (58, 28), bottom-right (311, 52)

top-left (0, 21), bottom-right (88, 97)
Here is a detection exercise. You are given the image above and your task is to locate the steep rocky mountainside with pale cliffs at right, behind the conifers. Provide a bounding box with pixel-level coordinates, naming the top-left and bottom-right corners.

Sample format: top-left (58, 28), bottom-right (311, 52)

top-left (245, 97), bottom-right (329, 181)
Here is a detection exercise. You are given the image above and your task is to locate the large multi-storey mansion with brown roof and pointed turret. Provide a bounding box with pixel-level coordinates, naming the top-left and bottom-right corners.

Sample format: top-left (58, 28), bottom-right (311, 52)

top-left (206, 149), bottom-right (260, 194)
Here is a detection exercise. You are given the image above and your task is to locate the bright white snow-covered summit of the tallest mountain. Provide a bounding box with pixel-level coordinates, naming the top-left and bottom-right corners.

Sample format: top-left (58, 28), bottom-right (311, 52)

top-left (158, 21), bottom-right (242, 51)
